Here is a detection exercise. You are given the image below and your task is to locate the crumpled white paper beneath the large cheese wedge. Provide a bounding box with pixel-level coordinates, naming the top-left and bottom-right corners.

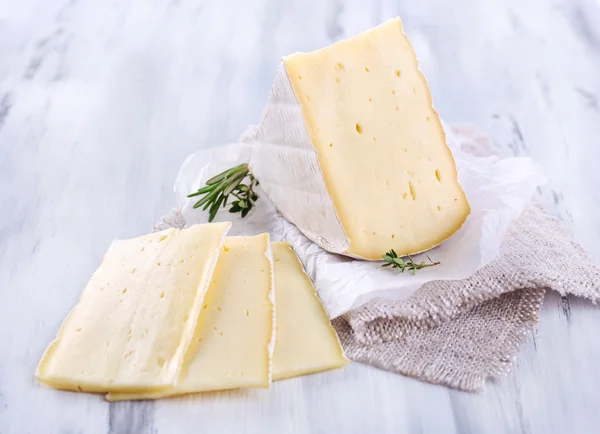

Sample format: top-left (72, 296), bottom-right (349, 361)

top-left (175, 126), bottom-right (545, 318)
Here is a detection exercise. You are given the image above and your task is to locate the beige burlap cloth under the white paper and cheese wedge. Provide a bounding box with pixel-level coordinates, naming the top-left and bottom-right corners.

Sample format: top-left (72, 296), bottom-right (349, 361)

top-left (155, 126), bottom-right (600, 391)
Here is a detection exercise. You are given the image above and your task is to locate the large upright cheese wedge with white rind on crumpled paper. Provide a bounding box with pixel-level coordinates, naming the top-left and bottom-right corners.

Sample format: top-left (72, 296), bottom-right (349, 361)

top-left (250, 18), bottom-right (470, 260)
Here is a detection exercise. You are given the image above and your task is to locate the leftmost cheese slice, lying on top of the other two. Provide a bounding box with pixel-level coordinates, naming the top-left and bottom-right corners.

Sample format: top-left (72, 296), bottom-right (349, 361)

top-left (37, 223), bottom-right (231, 392)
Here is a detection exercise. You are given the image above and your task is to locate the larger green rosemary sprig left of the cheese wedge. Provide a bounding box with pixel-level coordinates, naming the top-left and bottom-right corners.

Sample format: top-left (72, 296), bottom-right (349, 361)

top-left (188, 163), bottom-right (258, 222)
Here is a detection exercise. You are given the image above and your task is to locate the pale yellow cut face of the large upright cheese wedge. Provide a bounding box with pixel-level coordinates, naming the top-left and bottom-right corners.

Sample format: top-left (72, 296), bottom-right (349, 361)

top-left (284, 19), bottom-right (470, 259)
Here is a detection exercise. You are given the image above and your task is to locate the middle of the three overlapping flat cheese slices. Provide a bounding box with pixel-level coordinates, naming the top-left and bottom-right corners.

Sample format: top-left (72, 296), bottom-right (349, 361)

top-left (106, 234), bottom-right (275, 401)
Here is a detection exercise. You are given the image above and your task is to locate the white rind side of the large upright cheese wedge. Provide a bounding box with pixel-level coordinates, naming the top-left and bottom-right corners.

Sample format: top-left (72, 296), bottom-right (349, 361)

top-left (250, 63), bottom-right (350, 254)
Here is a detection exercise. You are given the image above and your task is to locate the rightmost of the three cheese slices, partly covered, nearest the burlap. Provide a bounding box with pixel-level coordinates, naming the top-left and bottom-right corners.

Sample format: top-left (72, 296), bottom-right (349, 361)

top-left (273, 243), bottom-right (348, 380)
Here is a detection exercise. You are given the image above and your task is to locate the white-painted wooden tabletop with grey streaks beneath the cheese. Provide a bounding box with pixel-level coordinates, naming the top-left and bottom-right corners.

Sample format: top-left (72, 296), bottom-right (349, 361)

top-left (0, 0), bottom-right (600, 434)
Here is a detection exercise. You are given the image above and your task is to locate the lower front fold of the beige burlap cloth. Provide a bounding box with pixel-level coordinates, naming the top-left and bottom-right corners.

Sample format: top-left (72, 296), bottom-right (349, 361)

top-left (333, 289), bottom-right (544, 391)
